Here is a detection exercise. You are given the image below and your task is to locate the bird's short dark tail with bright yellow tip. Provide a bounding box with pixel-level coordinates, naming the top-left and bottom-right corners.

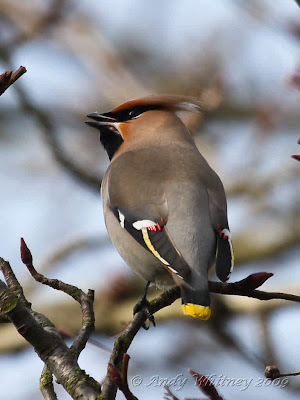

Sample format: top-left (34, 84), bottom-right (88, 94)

top-left (181, 276), bottom-right (211, 320)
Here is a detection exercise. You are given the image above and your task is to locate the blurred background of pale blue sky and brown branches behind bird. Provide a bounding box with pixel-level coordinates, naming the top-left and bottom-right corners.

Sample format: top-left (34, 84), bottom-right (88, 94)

top-left (0, 0), bottom-right (300, 400)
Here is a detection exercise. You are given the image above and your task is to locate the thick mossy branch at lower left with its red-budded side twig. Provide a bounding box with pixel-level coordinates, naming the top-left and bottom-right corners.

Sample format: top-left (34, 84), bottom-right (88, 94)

top-left (0, 239), bottom-right (101, 399)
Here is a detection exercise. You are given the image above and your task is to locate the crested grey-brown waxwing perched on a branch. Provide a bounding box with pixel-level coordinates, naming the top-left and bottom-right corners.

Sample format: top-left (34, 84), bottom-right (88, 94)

top-left (86, 95), bottom-right (234, 322)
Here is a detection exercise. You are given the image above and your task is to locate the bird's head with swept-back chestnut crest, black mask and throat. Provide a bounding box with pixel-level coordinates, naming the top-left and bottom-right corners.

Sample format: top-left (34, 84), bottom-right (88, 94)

top-left (86, 95), bottom-right (201, 160)
